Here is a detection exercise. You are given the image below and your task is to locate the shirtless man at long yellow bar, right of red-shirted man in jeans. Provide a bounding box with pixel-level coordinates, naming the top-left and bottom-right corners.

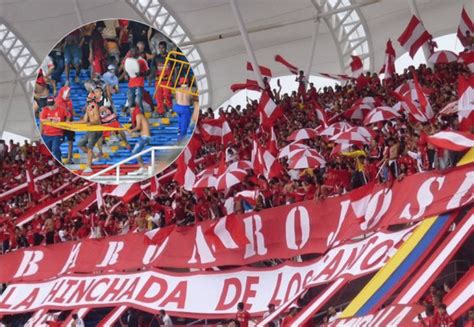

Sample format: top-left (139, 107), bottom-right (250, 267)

top-left (71, 102), bottom-right (102, 173)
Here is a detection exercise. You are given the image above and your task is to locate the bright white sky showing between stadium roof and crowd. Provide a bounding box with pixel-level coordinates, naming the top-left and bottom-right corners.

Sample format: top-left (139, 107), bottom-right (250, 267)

top-left (2, 33), bottom-right (463, 144)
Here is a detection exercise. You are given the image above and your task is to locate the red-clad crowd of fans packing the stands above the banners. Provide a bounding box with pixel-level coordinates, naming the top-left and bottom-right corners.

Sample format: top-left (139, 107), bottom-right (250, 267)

top-left (0, 52), bottom-right (473, 255)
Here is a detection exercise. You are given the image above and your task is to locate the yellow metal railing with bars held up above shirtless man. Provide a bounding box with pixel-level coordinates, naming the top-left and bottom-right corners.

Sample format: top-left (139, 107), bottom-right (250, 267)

top-left (155, 51), bottom-right (199, 96)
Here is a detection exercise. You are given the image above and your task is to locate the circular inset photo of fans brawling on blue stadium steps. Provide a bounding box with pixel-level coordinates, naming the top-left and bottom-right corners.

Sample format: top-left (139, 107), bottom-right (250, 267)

top-left (33, 19), bottom-right (199, 184)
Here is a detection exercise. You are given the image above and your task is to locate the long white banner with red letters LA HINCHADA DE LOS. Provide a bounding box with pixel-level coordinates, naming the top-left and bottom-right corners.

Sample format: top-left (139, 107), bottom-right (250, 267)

top-left (0, 227), bottom-right (414, 318)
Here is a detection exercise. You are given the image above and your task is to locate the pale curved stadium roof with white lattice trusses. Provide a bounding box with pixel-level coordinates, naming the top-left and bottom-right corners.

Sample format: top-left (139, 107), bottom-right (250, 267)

top-left (0, 0), bottom-right (468, 138)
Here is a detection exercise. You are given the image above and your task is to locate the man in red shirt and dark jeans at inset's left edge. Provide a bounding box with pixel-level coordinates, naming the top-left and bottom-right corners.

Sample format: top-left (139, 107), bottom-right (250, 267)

top-left (40, 97), bottom-right (67, 161)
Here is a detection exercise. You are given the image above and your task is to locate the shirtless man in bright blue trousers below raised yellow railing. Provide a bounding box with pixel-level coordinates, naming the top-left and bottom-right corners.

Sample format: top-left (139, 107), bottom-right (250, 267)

top-left (173, 78), bottom-right (199, 142)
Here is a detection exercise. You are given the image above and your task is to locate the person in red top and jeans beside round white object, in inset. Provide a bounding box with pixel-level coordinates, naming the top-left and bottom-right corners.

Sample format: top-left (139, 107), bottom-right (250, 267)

top-left (124, 48), bottom-right (148, 114)
